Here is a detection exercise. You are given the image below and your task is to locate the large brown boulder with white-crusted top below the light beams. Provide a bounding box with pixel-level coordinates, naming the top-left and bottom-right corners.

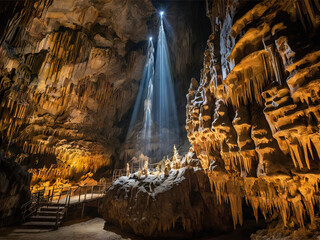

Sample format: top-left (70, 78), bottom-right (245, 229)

top-left (102, 167), bottom-right (232, 237)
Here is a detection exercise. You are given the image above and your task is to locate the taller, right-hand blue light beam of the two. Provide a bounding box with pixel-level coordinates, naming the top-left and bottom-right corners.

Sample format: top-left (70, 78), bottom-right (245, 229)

top-left (153, 16), bottom-right (179, 154)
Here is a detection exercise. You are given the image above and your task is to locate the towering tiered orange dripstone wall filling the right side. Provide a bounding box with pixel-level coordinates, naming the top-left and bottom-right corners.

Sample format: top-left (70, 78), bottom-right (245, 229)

top-left (186, 0), bottom-right (320, 233)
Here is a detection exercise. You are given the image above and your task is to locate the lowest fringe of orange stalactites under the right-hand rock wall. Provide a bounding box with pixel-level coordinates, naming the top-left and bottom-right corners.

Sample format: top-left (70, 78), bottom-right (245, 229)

top-left (209, 172), bottom-right (320, 230)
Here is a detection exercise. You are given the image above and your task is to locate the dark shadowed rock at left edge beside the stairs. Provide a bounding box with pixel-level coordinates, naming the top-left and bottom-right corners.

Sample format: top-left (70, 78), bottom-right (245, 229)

top-left (0, 155), bottom-right (31, 227)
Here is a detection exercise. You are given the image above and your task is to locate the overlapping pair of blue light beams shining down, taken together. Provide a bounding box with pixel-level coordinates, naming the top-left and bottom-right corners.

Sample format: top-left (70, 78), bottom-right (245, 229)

top-left (126, 15), bottom-right (179, 160)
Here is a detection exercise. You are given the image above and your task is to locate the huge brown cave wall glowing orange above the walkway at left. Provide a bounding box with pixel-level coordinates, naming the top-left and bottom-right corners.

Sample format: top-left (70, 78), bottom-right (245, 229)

top-left (0, 0), bottom-right (154, 186)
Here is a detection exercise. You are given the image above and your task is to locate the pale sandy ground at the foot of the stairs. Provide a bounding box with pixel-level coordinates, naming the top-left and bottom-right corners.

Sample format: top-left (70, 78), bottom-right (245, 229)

top-left (0, 218), bottom-right (130, 240)
